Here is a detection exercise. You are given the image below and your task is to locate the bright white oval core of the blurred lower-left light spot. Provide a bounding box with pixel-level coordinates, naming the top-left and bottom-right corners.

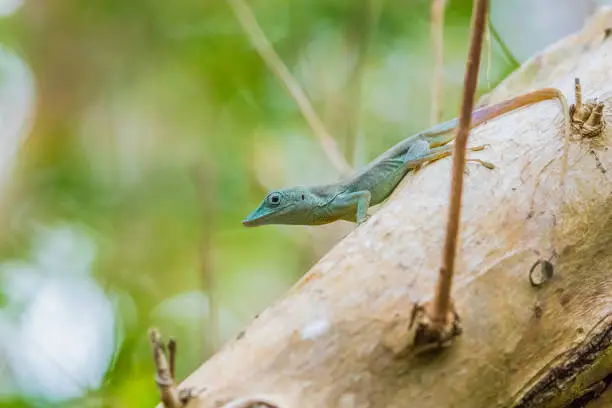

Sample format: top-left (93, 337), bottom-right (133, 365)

top-left (7, 279), bottom-right (114, 400)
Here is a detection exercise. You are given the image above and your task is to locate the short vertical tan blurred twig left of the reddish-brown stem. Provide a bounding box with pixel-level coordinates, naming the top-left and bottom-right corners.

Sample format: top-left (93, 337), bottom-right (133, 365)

top-left (430, 0), bottom-right (446, 125)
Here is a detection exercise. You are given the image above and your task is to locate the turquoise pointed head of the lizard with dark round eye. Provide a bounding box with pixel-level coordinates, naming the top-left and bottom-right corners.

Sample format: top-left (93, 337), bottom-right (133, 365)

top-left (242, 187), bottom-right (312, 227)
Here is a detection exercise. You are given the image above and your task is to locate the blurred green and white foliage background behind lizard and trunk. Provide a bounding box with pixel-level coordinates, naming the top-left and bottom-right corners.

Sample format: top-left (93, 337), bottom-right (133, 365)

top-left (0, 0), bottom-right (609, 407)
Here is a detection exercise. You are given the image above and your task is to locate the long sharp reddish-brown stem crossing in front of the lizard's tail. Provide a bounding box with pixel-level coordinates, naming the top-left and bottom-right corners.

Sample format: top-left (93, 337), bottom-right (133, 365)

top-left (431, 0), bottom-right (489, 325)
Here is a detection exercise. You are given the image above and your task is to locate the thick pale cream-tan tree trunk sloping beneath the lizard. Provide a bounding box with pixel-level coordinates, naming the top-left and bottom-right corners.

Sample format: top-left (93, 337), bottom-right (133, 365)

top-left (163, 9), bottom-right (612, 408)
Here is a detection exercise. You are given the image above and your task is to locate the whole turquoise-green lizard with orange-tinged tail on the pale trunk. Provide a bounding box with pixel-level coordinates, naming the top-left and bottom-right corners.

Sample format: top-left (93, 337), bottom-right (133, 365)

top-left (242, 88), bottom-right (567, 227)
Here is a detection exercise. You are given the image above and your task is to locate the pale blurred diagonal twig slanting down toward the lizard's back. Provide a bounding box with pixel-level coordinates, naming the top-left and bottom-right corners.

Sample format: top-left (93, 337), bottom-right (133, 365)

top-left (227, 0), bottom-right (351, 175)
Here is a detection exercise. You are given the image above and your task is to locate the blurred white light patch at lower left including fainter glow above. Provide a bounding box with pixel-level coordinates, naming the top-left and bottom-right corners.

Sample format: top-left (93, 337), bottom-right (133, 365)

top-left (0, 226), bottom-right (116, 401)
